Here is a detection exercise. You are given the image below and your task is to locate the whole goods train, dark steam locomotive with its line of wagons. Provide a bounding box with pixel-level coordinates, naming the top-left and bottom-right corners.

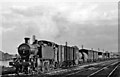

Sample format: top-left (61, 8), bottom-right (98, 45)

top-left (9, 36), bottom-right (117, 74)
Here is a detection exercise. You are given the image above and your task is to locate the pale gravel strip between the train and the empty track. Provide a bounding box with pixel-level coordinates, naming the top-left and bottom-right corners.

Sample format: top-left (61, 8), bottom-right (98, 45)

top-left (2, 61), bottom-right (118, 77)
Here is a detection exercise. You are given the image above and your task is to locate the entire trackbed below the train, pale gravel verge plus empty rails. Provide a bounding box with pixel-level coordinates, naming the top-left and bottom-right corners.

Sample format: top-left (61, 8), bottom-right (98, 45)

top-left (2, 60), bottom-right (120, 77)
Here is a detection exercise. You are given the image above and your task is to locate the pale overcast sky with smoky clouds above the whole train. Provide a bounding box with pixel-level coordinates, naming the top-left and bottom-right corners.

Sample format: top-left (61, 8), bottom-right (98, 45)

top-left (0, 0), bottom-right (118, 54)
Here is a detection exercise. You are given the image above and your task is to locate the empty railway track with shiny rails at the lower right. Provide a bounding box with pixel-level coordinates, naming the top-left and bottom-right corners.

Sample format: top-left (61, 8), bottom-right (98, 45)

top-left (58, 61), bottom-right (120, 77)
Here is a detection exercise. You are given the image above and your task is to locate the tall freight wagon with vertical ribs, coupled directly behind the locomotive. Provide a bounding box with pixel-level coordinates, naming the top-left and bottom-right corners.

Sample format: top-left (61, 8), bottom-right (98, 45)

top-left (58, 45), bottom-right (79, 67)
